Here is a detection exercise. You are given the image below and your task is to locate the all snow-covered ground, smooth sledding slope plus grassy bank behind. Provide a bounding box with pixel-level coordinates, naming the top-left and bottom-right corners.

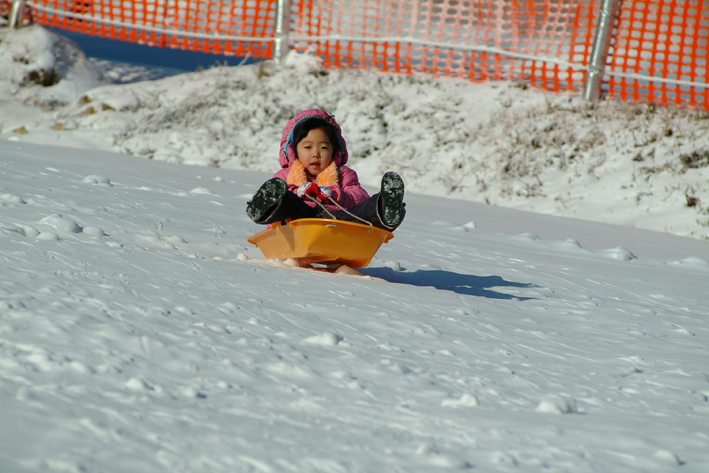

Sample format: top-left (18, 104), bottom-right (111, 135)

top-left (0, 25), bottom-right (709, 473)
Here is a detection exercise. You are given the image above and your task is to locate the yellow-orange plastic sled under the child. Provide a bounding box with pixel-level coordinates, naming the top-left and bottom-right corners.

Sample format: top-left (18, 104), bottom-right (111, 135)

top-left (248, 218), bottom-right (394, 268)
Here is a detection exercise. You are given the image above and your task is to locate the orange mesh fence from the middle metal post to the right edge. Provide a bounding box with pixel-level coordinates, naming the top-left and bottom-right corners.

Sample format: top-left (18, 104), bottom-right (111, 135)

top-left (294, 0), bottom-right (709, 110)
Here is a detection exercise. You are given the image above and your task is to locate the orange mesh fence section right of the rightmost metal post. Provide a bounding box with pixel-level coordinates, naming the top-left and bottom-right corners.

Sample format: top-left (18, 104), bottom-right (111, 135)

top-left (604, 0), bottom-right (709, 110)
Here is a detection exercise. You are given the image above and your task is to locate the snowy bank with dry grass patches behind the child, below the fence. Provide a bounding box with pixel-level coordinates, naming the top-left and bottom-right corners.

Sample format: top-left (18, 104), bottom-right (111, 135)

top-left (0, 24), bottom-right (709, 239)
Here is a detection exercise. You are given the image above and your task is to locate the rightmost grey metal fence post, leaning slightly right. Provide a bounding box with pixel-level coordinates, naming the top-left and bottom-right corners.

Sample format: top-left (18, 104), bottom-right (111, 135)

top-left (583, 0), bottom-right (620, 104)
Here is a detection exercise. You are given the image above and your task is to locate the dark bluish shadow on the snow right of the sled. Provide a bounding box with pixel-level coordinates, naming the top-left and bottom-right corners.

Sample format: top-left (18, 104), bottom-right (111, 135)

top-left (359, 268), bottom-right (539, 301)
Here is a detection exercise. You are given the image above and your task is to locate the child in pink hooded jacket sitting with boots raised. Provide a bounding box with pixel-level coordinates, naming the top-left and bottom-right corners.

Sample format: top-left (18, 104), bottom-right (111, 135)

top-left (246, 109), bottom-right (406, 231)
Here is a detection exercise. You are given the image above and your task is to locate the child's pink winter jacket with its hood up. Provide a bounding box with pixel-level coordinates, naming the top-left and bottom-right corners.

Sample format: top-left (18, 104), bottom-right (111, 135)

top-left (273, 109), bottom-right (369, 210)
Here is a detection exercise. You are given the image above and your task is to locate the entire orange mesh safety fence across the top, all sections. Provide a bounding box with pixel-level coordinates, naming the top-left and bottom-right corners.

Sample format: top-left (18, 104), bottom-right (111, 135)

top-left (0, 0), bottom-right (709, 110)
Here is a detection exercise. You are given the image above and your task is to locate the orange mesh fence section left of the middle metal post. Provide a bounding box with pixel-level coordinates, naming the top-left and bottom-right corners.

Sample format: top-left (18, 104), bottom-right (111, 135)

top-left (22, 0), bottom-right (276, 58)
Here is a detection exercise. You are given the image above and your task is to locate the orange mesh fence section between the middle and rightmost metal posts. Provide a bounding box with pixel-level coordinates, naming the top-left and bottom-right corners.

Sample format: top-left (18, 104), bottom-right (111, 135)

top-left (294, 0), bottom-right (600, 91)
